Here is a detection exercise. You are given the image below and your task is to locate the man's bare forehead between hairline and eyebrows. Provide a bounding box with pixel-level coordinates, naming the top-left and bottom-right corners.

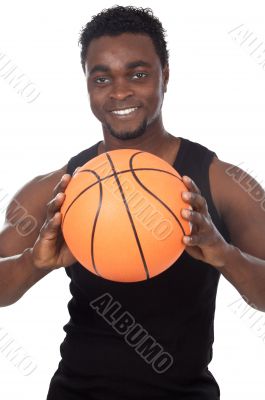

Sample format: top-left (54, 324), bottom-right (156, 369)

top-left (86, 33), bottom-right (160, 70)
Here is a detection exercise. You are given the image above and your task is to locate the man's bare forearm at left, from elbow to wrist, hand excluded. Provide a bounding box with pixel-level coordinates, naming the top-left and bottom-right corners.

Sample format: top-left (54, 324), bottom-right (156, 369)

top-left (0, 248), bottom-right (52, 307)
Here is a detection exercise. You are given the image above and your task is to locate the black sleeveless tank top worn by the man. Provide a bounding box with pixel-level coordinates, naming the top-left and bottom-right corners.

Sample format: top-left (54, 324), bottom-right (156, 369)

top-left (47, 138), bottom-right (230, 400)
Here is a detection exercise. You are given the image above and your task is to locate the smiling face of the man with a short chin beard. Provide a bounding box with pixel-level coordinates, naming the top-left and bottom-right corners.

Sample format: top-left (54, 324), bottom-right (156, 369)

top-left (83, 33), bottom-right (168, 140)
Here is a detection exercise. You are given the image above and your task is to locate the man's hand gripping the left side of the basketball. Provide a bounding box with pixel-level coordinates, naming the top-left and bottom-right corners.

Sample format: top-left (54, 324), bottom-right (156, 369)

top-left (32, 168), bottom-right (78, 269)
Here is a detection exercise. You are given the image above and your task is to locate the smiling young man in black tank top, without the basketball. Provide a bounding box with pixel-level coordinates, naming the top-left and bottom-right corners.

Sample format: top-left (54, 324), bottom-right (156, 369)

top-left (0, 6), bottom-right (265, 400)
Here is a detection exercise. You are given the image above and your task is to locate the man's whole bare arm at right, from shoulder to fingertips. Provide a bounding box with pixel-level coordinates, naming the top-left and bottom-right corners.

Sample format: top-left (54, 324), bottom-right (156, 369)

top-left (182, 159), bottom-right (265, 311)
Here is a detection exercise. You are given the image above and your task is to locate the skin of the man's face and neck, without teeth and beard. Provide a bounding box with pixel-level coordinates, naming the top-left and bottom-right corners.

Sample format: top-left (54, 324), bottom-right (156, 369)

top-left (86, 34), bottom-right (176, 160)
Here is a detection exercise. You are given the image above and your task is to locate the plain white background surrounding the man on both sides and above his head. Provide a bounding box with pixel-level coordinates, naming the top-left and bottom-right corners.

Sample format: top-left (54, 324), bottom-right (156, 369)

top-left (0, 0), bottom-right (265, 400)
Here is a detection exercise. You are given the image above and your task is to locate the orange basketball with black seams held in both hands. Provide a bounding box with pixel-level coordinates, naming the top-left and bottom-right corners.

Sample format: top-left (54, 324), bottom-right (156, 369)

top-left (61, 149), bottom-right (190, 282)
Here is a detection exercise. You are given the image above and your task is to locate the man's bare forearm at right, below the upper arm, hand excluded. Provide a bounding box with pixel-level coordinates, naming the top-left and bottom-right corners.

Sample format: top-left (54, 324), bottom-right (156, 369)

top-left (218, 245), bottom-right (265, 312)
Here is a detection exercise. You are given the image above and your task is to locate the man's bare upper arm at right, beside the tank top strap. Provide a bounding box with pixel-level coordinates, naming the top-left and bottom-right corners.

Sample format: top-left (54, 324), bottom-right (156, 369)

top-left (211, 162), bottom-right (265, 259)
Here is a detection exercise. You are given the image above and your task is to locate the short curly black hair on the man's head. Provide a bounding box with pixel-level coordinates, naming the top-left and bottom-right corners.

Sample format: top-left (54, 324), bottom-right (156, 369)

top-left (78, 5), bottom-right (169, 72)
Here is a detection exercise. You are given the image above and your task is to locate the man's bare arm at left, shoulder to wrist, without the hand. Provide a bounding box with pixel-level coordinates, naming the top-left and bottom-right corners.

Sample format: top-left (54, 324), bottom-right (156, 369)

top-left (0, 166), bottom-right (66, 307)
